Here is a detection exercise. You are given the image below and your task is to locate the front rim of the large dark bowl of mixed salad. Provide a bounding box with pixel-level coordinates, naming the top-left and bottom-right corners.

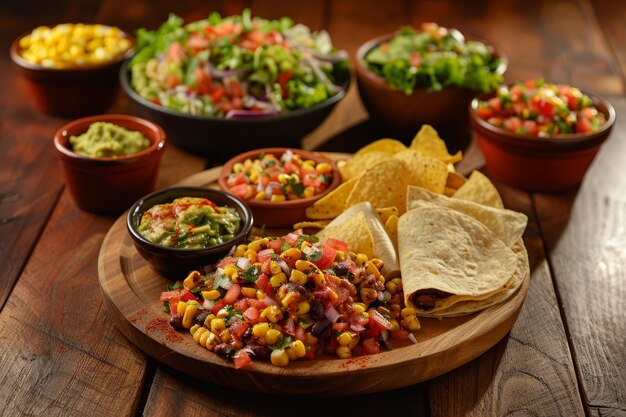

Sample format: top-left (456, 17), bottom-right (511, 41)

top-left (119, 60), bottom-right (352, 125)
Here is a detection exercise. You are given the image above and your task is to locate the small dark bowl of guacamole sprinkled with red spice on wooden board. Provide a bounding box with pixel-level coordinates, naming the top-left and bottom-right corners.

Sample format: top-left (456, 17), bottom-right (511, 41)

top-left (126, 187), bottom-right (253, 279)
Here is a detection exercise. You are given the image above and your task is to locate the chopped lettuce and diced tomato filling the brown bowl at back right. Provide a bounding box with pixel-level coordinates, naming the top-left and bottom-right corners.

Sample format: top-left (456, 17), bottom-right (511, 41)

top-left (364, 23), bottom-right (503, 95)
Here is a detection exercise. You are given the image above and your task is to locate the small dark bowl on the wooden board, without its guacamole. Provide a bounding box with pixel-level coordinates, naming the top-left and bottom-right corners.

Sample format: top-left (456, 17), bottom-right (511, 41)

top-left (126, 187), bottom-right (253, 279)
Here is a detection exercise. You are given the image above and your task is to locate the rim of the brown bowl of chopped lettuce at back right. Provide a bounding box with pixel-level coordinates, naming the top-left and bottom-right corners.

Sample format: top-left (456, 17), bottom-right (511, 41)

top-left (354, 30), bottom-right (509, 94)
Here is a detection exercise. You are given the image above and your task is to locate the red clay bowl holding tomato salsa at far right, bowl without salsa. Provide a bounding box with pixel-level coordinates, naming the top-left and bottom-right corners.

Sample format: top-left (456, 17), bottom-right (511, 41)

top-left (469, 91), bottom-right (615, 191)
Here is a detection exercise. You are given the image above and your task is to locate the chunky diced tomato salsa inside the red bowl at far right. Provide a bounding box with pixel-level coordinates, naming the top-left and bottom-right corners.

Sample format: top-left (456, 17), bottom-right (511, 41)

top-left (476, 79), bottom-right (606, 137)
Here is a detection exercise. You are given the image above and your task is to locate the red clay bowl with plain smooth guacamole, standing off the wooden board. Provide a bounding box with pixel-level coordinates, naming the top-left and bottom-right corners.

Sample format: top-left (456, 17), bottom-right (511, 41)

top-left (54, 114), bottom-right (166, 214)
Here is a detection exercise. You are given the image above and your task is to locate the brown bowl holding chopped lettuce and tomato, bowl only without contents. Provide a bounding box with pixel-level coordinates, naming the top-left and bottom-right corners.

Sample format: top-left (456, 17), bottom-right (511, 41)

top-left (355, 33), bottom-right (507, 138)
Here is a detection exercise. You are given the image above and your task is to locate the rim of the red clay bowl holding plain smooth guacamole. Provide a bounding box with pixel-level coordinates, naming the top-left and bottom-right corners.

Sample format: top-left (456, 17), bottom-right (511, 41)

top-left (54, 114), bottom-right (166, 164)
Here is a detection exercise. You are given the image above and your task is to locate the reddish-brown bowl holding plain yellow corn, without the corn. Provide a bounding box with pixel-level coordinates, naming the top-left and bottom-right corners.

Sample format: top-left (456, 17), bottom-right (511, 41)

top-left (10, 26), bottom-right (134, 117)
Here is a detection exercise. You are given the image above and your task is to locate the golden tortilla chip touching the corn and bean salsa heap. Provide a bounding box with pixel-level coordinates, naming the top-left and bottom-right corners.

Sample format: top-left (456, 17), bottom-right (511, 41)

top-left (316, 212), bottom-right (374, 258)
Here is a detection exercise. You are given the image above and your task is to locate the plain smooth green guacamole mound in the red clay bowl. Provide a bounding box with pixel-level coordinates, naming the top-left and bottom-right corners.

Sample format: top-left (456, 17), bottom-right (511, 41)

top-left (70, 122), bottom-right (152, 158)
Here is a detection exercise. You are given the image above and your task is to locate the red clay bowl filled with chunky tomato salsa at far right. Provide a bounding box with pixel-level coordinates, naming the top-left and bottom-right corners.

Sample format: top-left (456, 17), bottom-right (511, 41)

top-left (469, 80), bottom-right (615, 191)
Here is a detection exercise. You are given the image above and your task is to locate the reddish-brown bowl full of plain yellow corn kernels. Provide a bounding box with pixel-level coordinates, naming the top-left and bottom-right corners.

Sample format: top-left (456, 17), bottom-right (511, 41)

top-left (10, 23), bottom-right (134, 116)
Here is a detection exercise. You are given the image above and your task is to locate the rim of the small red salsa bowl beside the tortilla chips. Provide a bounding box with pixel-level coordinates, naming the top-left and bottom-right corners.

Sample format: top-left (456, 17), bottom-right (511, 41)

top-left (217, 147), bottom-right (341, 210)
